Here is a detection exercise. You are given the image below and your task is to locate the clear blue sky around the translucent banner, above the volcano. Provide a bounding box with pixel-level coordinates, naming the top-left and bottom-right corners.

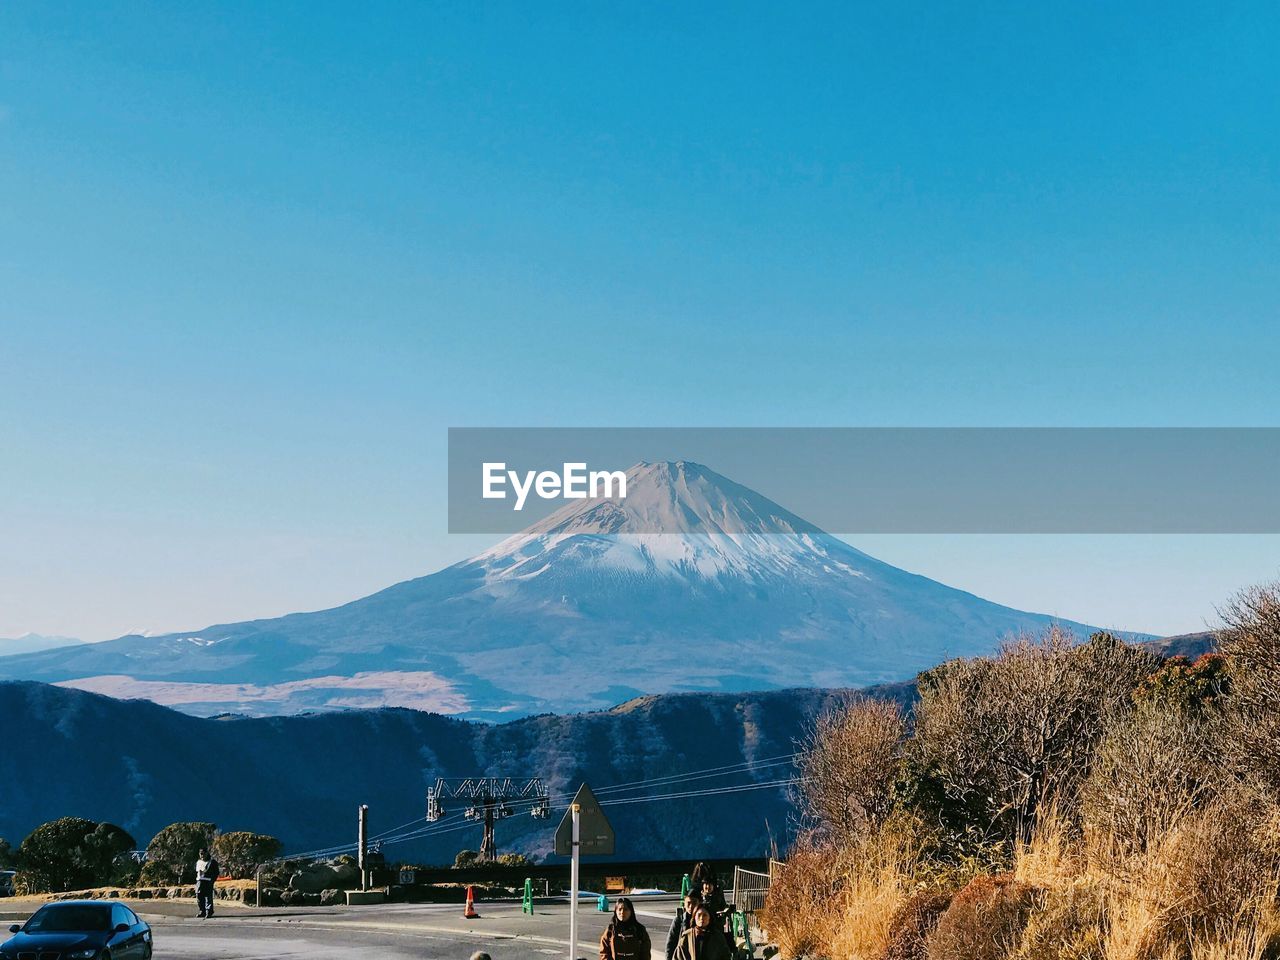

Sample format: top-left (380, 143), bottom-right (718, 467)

top-left (0, 3), bottom-right (1280, 639)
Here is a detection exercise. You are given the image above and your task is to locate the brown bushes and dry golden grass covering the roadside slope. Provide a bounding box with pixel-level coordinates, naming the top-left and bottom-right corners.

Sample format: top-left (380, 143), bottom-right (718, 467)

top-left (762, 585), bottom-right (1280, 960)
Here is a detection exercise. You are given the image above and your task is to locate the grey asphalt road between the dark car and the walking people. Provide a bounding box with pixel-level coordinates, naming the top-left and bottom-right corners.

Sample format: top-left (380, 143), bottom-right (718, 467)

top-left (0, 896), bottom-right (676, 960)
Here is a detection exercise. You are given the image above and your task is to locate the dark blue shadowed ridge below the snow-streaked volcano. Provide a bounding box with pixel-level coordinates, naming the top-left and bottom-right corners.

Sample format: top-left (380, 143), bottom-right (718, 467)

top-left (0, 682), bottom-right (911, 863)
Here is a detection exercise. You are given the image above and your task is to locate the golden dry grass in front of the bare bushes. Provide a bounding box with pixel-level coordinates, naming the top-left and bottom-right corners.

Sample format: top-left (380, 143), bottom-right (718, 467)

top-left (764, 790), bottom-right (1280, 960)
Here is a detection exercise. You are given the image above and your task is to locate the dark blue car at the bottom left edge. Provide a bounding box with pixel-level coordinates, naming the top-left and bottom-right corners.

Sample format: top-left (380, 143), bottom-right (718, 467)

top-left (0, 900), bottom-right (151, 960)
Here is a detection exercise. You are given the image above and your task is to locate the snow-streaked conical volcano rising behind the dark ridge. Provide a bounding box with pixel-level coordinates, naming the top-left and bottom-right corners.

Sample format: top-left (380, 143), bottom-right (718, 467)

top-left (0, 461), bottom-right (1141, 719)
